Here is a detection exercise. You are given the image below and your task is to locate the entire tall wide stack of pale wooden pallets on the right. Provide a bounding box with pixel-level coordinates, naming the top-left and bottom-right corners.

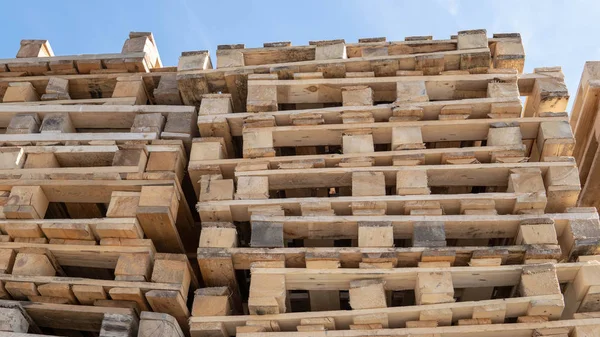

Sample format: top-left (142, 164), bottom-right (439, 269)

top-left (189, 31), bottom-right (600, 337)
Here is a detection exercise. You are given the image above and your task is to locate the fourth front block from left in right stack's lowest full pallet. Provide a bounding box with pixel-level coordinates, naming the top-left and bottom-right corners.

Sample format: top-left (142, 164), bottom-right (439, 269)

top-left (415, 272), bottom-right (454, 305)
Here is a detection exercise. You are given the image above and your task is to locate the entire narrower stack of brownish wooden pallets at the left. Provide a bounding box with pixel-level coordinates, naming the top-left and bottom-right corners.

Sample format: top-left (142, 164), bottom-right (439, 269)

top-left (0, 33), bottom-right (199, 336)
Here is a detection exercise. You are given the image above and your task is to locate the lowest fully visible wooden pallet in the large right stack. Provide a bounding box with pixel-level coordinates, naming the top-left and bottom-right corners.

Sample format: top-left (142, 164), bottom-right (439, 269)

top-left (190, 259), bottom-right (599, 336)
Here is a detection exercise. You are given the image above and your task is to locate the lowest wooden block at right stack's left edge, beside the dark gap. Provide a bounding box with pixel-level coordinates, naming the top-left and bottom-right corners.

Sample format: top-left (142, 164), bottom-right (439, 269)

top-left (192, 287), bottom-right (231, 316)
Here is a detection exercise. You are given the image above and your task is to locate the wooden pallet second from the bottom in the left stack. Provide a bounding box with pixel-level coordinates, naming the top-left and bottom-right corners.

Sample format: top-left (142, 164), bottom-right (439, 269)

top-left (0, 243), bottom-right (198, 328)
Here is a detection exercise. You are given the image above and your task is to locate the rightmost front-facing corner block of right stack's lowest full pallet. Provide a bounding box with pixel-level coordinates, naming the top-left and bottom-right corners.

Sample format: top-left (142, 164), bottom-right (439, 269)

top-left (519, 264), bottom-right (561, 297)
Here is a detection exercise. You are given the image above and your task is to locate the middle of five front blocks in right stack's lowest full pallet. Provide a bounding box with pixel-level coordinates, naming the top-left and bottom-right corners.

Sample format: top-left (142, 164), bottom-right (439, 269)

top-left (349, 279), bottom-right (387, 310)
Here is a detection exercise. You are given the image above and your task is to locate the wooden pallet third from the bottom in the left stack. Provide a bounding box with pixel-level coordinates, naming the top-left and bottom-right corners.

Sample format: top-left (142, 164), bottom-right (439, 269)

top-left (0, 175), bottom-right (198, 253)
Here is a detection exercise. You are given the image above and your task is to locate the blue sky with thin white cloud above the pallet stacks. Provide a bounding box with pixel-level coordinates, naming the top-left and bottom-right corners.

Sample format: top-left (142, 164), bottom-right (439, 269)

top-left (0, 0), bottom-right (600, 107)
